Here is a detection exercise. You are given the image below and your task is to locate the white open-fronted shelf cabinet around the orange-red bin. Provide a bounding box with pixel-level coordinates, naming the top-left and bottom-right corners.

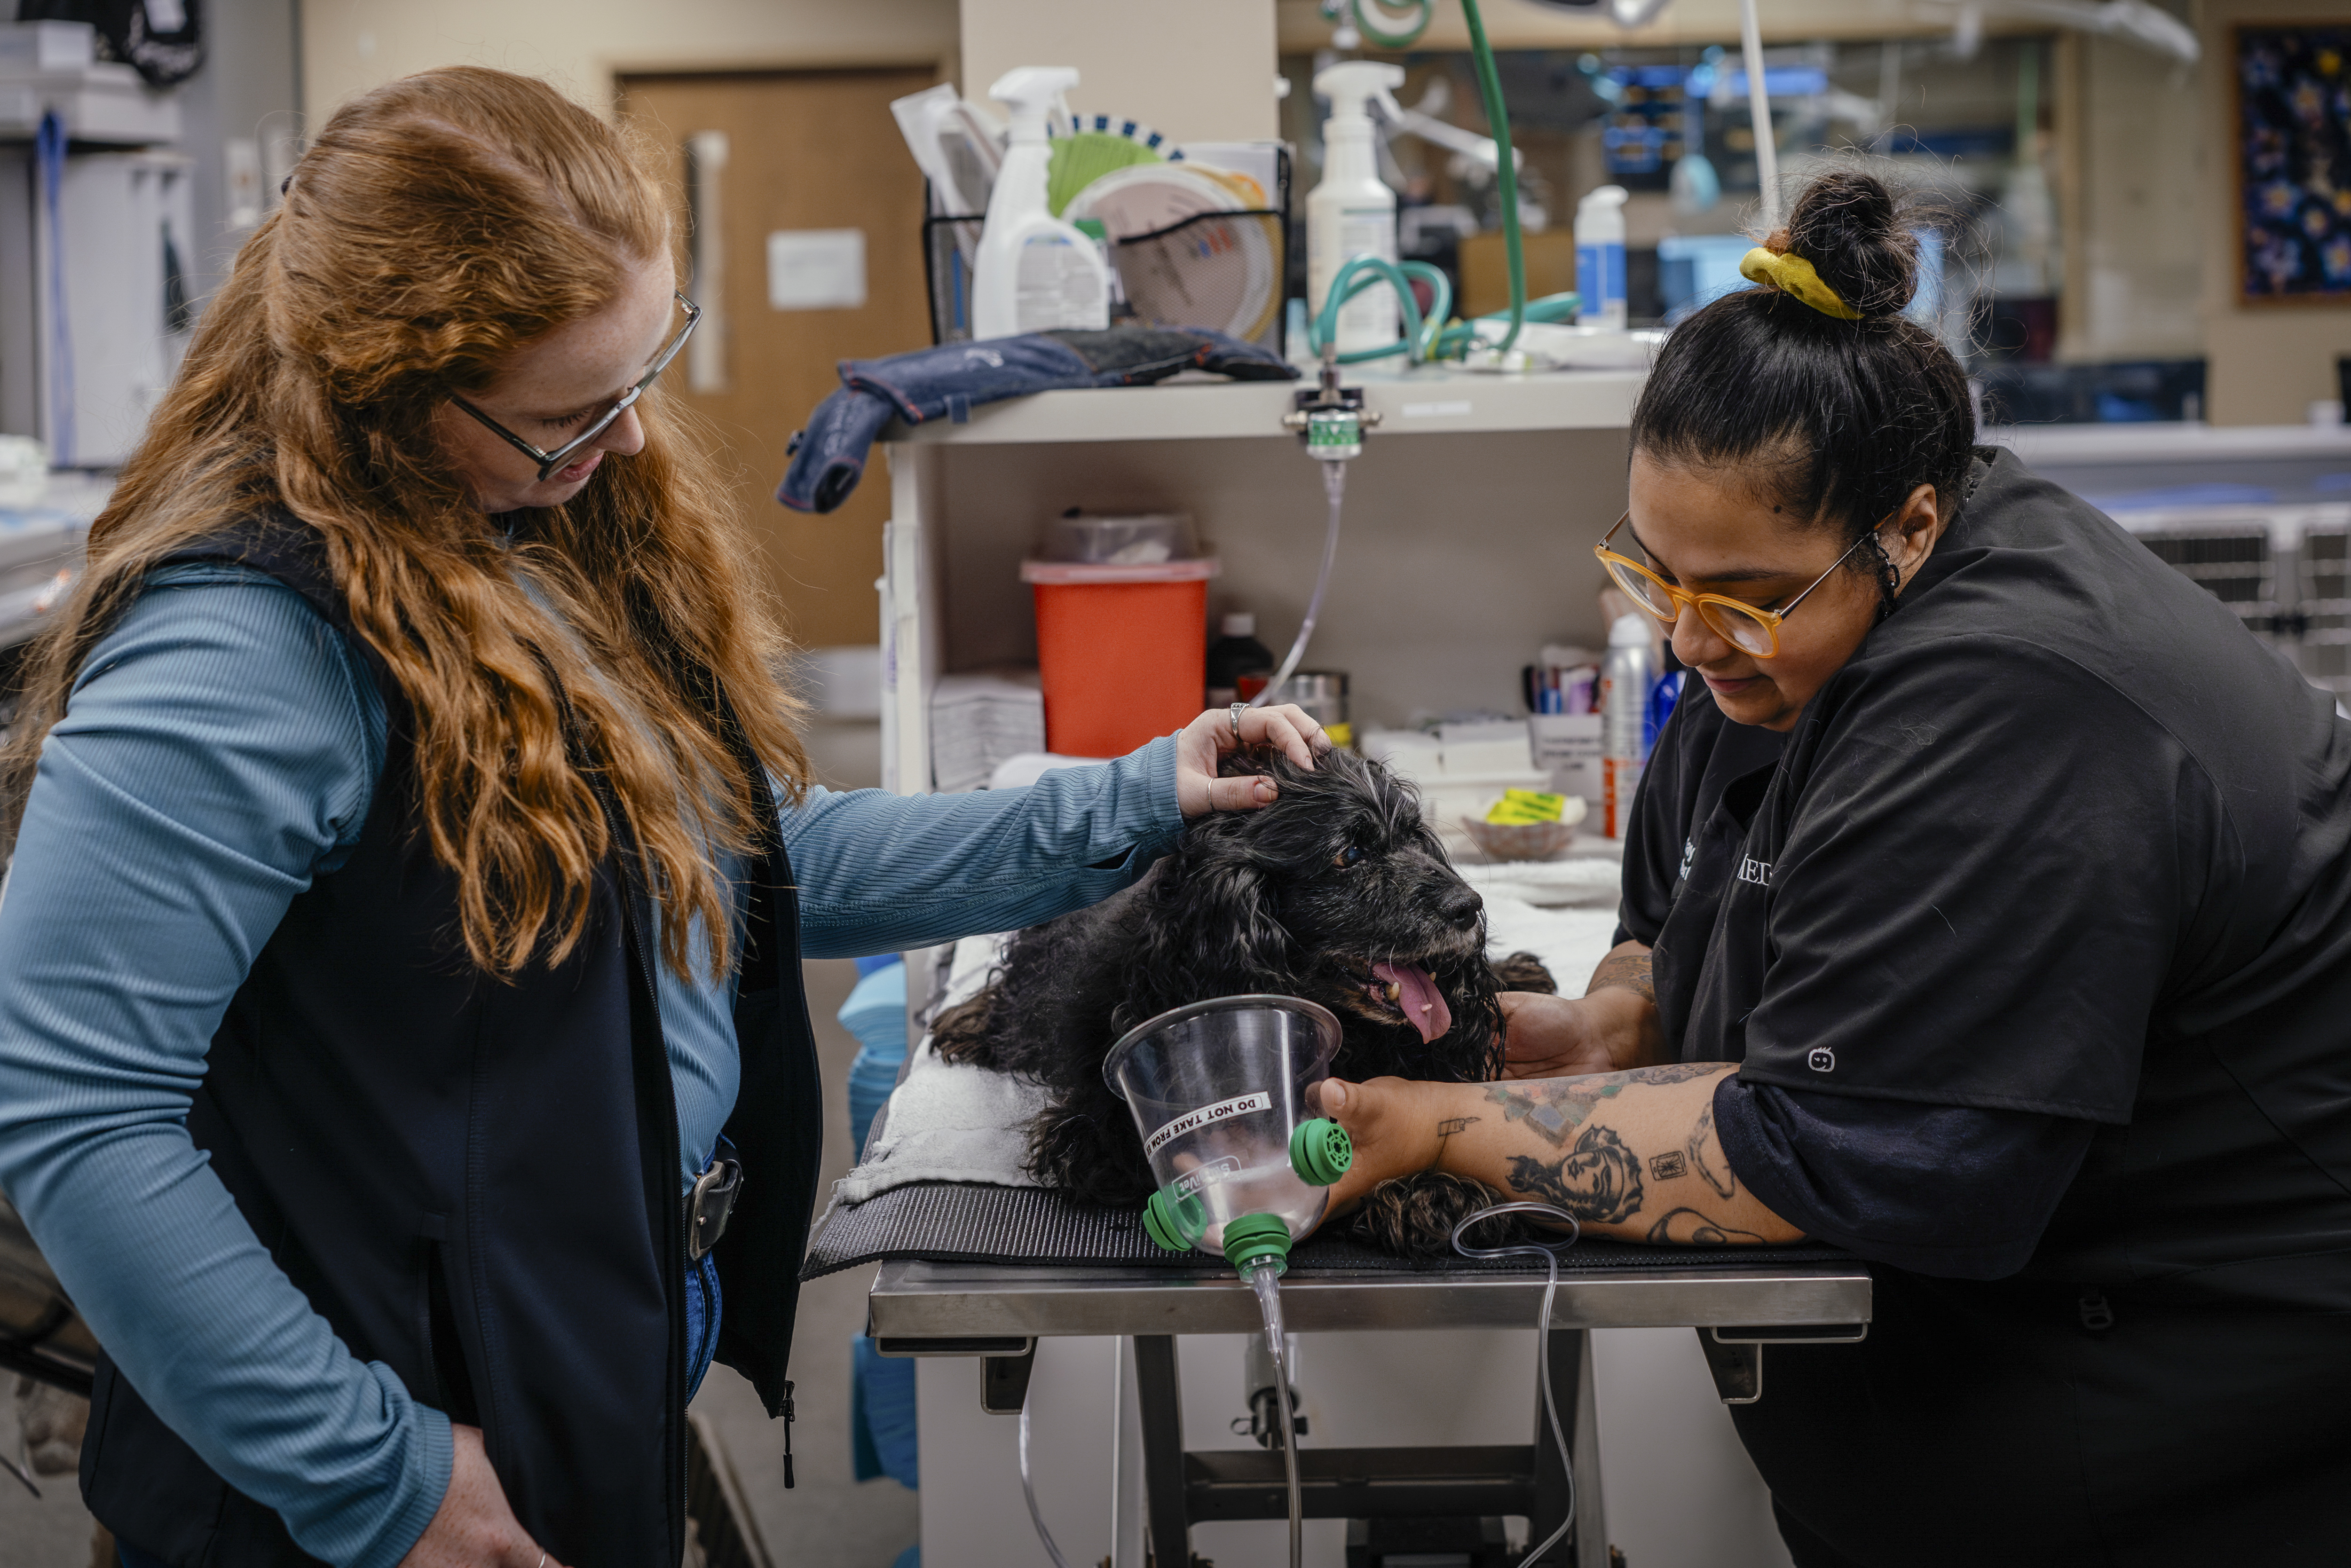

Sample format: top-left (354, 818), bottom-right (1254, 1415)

top-left (882, 367), bottom-right (1641, 792)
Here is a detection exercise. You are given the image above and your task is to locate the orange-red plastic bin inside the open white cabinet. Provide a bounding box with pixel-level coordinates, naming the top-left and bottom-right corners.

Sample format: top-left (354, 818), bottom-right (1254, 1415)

top-left (1020, 557), bottom-right (1220, 757)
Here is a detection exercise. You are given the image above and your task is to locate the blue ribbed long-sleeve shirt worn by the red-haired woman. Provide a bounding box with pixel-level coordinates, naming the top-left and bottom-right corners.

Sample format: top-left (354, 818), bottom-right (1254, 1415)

top-left (0, 567), bottom-right (1183, 1568)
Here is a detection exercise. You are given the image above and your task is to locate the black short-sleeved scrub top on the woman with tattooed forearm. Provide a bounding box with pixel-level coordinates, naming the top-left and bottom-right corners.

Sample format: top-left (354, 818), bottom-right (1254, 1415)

top-left (1620, 449), bottom-right (2351, 1309)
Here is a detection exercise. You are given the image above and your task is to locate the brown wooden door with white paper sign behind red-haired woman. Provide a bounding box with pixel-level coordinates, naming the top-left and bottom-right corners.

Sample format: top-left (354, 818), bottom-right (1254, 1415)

top-left (621, 68), bottom-right (938, 646)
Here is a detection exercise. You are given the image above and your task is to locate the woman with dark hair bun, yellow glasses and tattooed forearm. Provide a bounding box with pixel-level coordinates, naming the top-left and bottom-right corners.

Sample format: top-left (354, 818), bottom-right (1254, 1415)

top-left (1326, 172), bottom-right (2351, 1568)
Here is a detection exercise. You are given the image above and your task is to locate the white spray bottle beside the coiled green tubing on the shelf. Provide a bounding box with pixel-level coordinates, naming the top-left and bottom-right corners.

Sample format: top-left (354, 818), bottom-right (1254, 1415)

top-left (1307, 59), bottom-right (1404, 355)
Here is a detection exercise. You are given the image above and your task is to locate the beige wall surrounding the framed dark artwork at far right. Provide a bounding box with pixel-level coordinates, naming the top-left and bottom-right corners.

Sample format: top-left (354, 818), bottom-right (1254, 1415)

top-left (2198, 0), bottom-right (2351, 425)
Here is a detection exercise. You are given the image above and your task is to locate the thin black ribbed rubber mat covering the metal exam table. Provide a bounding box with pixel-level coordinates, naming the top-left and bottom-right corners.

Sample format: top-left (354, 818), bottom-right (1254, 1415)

top-left (799, 1182), bottom-right (1855, 1279)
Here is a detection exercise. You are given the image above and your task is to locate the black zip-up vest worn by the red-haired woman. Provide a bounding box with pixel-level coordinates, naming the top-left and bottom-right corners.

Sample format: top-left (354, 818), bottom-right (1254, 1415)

top-left (82, 515), bottom-right (823, 1568)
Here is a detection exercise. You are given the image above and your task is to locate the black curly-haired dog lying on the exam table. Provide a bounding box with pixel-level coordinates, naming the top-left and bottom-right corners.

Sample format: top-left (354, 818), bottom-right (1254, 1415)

top-left (933, 752), bottom-right (1556, 1258)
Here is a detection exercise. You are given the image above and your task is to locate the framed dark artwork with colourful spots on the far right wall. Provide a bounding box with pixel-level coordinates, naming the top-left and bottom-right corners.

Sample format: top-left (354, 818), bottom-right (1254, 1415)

top-left (2231, 24), bottom-right (2351, 303)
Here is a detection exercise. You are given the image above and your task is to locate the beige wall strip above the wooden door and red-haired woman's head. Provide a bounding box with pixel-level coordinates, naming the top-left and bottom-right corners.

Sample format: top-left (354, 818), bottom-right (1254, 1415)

top-left (301, 0), bottom-right (957, 125)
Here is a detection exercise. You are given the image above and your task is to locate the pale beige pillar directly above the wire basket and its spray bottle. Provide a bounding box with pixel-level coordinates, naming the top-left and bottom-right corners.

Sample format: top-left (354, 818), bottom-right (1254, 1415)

top-left (962, 0), bottom-right (1279, 141)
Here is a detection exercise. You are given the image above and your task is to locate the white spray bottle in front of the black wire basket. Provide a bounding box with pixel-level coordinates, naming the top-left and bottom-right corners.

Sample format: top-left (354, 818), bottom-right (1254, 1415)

top-left (971, 66), bottom-right (1110, 339)
